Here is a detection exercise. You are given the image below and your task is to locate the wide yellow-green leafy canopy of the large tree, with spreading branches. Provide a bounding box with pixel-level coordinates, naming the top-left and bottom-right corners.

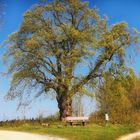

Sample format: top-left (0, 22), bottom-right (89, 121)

top-left (4, 0), bottom-right (139, 118)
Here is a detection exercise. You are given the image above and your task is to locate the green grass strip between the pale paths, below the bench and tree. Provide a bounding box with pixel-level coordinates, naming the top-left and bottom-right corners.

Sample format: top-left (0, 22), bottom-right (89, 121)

top-left (0, 123), bottom-right (140, 140)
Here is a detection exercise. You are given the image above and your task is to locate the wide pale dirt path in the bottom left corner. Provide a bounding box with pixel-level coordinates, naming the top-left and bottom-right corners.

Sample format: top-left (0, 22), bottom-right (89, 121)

top-left (0, 131), bottom-right (66, 140)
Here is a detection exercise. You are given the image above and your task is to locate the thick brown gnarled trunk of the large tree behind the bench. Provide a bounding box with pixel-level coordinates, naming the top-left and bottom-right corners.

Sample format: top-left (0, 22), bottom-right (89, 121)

top-left (57, 94), bottom-right (72, 121)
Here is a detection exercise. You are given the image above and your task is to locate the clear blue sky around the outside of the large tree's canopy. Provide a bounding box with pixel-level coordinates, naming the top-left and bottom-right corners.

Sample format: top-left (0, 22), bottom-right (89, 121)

top-left (0, 0), bottom-right (140, 120)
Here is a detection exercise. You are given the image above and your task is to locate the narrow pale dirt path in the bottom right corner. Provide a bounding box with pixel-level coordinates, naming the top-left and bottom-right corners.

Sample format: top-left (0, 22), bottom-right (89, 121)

top-left (117, 131), bottom-right (140, 140)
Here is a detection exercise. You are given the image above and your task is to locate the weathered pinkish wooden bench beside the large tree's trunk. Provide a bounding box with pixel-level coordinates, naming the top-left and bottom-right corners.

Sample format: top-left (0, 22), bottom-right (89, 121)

top-left (65, 117), bottom-right (89, 126)
